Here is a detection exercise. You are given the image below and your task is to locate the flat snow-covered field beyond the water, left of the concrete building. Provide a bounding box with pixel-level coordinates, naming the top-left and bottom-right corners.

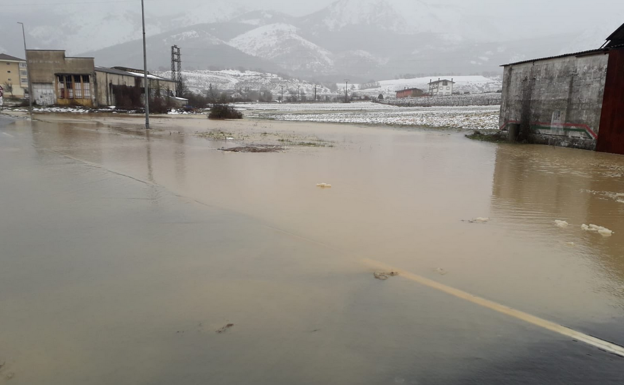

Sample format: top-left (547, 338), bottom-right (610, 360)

top-left (235, 103), bottom-right (500, 130)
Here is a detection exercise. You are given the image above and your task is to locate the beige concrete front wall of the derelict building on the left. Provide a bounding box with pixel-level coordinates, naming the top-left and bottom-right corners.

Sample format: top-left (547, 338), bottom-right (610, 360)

top-left (26, 51), bottom-right (97, 107)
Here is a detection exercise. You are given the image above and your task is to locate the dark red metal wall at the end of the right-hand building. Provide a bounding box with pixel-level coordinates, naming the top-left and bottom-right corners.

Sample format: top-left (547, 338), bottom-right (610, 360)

top-left (596, 48), bottom-right (624, 154)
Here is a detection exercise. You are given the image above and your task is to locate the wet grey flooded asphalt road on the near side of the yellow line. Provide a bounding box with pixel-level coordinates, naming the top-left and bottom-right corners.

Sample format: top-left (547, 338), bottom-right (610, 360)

top-left (0, 116), bottom-right (624, 385)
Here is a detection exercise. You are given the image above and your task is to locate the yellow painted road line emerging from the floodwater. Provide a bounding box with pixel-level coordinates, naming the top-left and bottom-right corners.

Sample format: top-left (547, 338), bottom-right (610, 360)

top-left (364, 259), bottom-right (624, 357)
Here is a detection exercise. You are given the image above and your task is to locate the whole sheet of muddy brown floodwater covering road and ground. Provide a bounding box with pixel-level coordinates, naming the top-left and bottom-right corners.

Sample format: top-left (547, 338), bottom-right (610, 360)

top-left (0, 112), bottom-right (624, 385)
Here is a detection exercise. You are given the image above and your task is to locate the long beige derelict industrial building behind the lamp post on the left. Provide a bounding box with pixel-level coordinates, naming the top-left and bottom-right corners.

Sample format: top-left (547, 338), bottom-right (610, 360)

top-left (26, 50), bottom-right (179, 107)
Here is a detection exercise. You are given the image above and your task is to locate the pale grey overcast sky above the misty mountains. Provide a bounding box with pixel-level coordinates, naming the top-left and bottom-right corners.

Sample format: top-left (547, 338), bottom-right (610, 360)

top-left (0, 0), bottom-right (624, 57)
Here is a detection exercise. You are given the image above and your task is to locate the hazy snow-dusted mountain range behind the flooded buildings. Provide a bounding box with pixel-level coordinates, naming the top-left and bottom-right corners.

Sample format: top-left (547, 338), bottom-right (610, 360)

top-left (0, 0), bottom-right (624, 81)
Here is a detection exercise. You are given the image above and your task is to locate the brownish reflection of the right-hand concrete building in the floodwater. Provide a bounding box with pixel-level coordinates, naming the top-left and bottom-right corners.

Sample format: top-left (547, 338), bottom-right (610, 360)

top-left (492, 145), bottom-right (624, 279)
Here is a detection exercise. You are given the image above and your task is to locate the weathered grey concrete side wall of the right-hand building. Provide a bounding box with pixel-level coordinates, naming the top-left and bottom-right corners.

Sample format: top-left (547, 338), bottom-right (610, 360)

top-left (500, 52), bottom-right (608, 150)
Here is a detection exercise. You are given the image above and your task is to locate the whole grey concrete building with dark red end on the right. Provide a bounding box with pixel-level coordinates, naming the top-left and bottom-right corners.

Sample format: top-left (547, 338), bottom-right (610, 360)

top-left (500, 25), bottom-right (624, 154)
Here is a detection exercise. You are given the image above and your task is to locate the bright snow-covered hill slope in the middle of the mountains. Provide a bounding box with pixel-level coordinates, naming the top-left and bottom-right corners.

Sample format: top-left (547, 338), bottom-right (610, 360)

top-left (229, 23), bottom-right (334, 73)
